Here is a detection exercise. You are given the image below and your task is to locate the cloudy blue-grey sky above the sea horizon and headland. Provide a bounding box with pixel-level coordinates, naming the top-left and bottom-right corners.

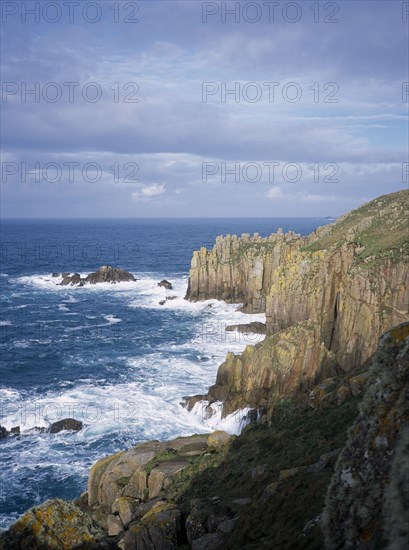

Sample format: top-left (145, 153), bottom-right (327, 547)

top-left (1, 0), bottom-right (409, 218)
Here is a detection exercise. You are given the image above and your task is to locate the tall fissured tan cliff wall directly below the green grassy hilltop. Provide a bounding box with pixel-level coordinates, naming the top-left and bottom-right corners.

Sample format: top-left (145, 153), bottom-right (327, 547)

top-left (266, 243), bottom-right (409, 370)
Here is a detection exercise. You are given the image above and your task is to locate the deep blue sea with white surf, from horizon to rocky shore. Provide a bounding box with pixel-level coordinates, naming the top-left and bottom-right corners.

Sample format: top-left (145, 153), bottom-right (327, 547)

top-left (0, 218), bottom-right (327, 529)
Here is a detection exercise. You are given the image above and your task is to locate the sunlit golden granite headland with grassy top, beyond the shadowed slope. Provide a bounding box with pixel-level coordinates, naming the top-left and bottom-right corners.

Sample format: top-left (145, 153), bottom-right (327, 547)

top-left (187, 191), bottom-right (409, 413)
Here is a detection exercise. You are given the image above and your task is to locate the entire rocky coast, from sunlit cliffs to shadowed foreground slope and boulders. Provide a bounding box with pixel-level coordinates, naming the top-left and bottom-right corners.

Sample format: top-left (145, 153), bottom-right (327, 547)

top-left (0, 191), bottom-right (409, 550)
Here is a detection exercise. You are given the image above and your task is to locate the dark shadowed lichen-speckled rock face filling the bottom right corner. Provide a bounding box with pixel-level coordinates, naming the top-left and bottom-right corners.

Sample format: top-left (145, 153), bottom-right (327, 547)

top-left (323, 323), bottom-right (409, 550)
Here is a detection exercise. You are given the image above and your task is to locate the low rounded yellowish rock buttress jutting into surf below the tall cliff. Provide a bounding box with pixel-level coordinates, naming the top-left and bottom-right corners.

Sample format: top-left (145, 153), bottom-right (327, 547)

top-left (188, 321), bottom-right (335, 415)
